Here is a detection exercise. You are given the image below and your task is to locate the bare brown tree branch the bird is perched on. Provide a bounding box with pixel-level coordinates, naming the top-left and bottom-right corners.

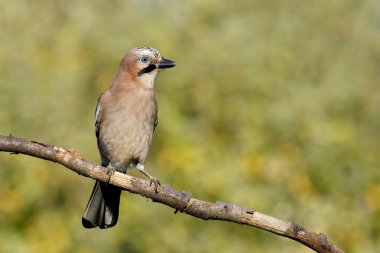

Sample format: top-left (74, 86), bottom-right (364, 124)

top-left (0, 135), bottom-right (343, 253)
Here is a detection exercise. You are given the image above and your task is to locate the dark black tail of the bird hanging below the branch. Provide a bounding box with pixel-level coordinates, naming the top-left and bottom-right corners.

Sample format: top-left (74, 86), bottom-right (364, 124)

top-left (82, 181), bottom-right (121, 228)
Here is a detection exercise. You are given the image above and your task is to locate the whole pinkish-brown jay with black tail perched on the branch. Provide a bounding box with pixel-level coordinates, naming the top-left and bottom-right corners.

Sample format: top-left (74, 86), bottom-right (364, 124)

top-left (82, 46), bottom-right (176, 229)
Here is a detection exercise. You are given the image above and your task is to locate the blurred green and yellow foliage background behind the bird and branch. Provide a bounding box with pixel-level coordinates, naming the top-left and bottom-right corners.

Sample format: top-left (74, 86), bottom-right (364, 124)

top-left (0, 0), bottom-right (380, 253)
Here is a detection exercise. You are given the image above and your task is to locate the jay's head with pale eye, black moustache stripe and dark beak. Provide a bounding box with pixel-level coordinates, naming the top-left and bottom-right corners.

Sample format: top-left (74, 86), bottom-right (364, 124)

top-left (120, 46), bottom-right (175, 87)
